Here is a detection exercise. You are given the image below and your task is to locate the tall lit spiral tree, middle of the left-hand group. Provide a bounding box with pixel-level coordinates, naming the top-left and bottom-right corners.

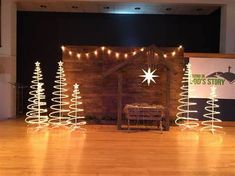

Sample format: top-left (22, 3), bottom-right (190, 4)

top-left (49, 61), bottom-right (69, 126)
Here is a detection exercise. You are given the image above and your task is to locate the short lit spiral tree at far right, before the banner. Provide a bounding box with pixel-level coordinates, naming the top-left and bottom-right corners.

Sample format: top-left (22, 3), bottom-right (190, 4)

top-left (201, 86), bottom-right (223, 134)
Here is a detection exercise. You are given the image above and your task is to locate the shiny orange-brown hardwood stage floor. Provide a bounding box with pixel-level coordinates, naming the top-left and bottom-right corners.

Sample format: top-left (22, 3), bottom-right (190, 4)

top-left (0, 119), bottom-right (235, 176)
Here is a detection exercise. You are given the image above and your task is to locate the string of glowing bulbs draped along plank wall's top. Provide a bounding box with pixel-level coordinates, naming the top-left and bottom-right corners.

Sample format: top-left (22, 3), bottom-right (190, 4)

top-left (61, 45), bottom-right (183, 59)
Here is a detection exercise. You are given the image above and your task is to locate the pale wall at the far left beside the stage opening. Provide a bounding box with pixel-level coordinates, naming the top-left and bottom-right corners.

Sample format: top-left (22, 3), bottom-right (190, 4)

top-left (0, 0), bottom-right (16, 120)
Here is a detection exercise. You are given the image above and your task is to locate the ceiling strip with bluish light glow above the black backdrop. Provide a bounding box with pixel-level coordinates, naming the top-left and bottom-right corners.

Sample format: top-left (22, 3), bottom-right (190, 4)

top-left (17, 1), bottom-right (220, 15)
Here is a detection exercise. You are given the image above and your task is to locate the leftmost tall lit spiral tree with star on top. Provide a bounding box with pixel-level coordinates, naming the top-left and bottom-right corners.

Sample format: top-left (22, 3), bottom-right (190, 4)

top-left (25, 62), bottom-right (48, 127)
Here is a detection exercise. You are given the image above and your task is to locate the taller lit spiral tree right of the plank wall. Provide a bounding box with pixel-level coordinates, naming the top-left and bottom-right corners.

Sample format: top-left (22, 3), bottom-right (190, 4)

top-left (175, 64), bottom-right (199, 130)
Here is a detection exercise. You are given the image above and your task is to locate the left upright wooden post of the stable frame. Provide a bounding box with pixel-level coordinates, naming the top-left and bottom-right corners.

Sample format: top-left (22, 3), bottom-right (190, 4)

top-left (117, 72), bottom-right (123, 130)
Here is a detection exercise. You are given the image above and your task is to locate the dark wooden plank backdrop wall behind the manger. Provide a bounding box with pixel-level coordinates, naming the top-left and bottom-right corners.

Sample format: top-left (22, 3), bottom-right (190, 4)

top-left (63, 46), bottom-right (183, 119)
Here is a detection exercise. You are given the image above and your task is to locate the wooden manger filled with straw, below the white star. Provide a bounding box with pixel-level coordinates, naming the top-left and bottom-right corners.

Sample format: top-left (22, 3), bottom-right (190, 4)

top-left (124, 104), bottom-right (165, 131)
